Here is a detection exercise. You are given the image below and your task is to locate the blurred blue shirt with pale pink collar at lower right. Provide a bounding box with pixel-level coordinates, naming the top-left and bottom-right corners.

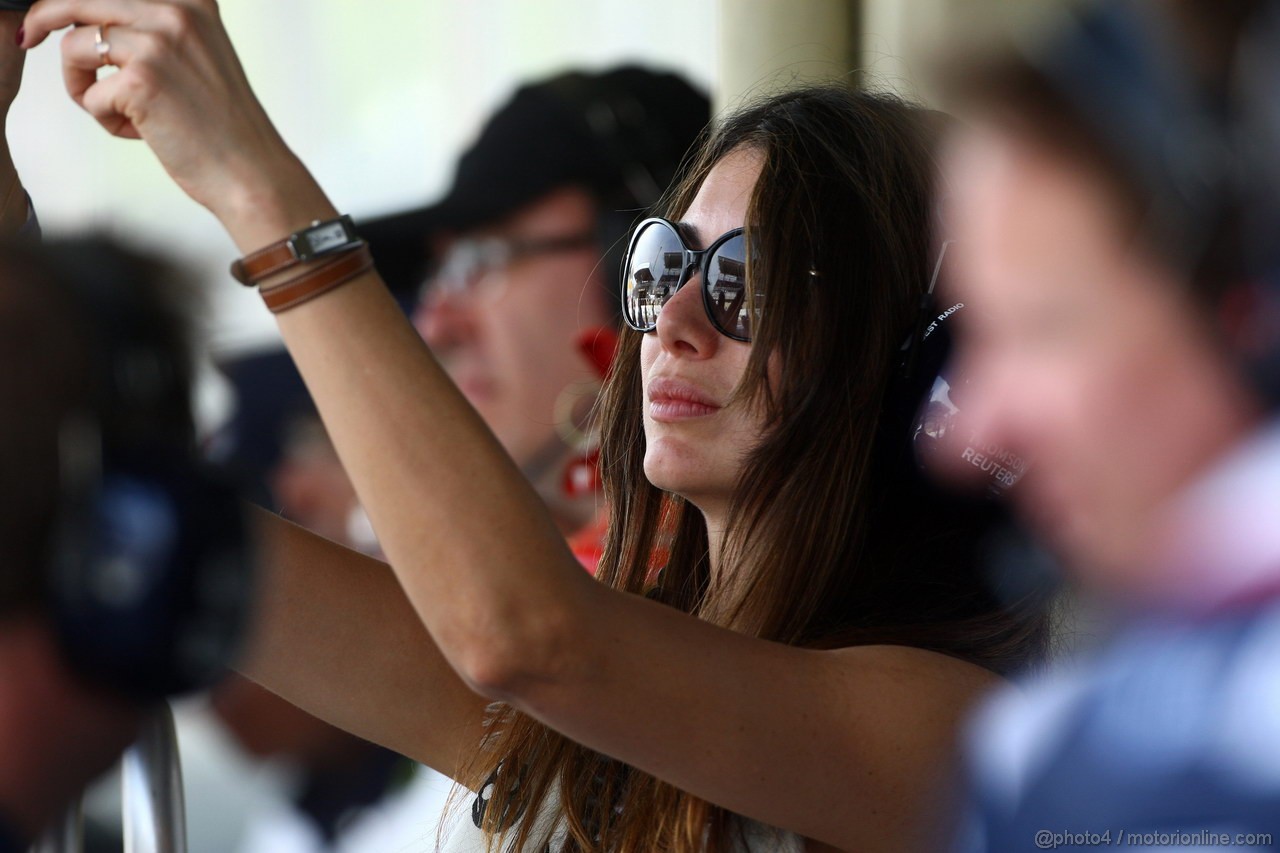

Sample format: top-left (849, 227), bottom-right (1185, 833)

top-left (957, 423), bottom-right (1280, 853)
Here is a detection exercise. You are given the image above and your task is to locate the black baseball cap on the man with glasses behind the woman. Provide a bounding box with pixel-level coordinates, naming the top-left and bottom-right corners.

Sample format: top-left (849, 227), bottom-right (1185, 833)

top-left (360, 65), bottom-right (710, 291)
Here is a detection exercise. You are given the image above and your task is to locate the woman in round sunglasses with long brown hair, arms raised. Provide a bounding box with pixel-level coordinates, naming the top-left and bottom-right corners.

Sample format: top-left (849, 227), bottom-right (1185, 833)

top-left (23, 0), bottom-right (1042, 850)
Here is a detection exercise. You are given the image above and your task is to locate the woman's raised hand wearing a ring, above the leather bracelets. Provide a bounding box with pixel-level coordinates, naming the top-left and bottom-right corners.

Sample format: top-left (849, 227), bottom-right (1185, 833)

top-left (22, 0), bottom-right (323, 240)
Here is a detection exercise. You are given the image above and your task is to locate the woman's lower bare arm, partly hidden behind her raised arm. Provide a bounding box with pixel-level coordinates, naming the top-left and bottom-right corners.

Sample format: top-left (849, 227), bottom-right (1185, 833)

top-left (239, 510), bottom-right (488, 775)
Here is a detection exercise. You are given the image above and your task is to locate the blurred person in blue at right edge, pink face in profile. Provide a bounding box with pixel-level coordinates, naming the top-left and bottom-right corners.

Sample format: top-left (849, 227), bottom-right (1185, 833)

top-left (926, 0), bottom-right (1280, 852)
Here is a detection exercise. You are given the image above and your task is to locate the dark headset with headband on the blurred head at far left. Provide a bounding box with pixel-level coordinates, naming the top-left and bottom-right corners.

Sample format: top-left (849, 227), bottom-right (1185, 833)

top-left (41, 238), bottom-right (252, 702)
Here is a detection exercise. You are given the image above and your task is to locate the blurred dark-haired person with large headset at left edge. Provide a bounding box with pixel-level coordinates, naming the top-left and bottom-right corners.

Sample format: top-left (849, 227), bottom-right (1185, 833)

top-left (0, 240), bottom-right (250, 852)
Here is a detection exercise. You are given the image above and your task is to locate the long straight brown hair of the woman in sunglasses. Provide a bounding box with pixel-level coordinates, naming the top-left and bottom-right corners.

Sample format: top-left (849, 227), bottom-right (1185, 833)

top-left (450, 86), bottom-right (1043, 852)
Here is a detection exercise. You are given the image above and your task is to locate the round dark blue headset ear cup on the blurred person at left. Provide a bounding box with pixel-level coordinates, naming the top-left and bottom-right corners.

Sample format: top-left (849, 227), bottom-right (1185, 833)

top-left (49, 453), bottom-right (251, 701)
